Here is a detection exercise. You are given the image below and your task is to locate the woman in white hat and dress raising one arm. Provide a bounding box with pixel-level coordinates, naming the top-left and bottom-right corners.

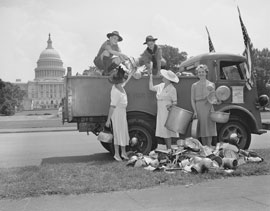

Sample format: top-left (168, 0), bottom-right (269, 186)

top-left (149, 68), bottom-right (179, 149)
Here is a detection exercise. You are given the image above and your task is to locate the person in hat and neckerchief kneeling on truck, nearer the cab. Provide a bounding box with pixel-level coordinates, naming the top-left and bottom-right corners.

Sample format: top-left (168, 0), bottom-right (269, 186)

top-left (139, 35), bottom-right (166, 75)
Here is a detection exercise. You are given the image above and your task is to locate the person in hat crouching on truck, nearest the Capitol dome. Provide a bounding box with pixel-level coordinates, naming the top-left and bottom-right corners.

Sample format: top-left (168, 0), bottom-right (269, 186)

top-left (94, 31), bottom-right (128, 75)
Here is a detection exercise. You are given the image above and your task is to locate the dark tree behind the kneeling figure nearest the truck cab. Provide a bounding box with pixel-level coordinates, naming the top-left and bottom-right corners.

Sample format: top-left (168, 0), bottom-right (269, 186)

top-left (160, 45), bottom-right (187, 72)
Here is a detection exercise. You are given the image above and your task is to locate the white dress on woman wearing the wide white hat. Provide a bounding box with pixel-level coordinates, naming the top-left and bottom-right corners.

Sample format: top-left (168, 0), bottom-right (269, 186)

top-left (154, 83), bottom-right (179, 138)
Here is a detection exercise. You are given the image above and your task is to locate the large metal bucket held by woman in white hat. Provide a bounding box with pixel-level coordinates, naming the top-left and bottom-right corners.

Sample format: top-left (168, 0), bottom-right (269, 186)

top-left (165, 106), bottom-right (193, 134)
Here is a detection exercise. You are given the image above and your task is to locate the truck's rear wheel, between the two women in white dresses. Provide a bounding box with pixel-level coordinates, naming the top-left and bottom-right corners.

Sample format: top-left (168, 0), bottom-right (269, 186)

top-left (128, 118), bottom-right (156, 154)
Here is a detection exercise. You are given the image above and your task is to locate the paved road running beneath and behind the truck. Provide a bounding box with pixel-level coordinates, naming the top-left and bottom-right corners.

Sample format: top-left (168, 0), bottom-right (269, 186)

top-left (0, 131), bottom-right (270, 168)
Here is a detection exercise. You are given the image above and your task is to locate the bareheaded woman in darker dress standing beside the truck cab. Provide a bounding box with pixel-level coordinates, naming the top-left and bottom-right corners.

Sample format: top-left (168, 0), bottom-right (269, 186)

top-left (191, 65), bottom-right (217, 147)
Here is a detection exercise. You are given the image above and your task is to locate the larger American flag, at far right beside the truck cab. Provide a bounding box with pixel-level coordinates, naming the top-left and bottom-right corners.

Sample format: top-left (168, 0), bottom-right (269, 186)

top-left (237, 7), bottom-right (253, 90)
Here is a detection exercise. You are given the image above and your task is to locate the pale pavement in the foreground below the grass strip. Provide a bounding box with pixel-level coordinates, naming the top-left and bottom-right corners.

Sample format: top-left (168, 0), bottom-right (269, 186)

top-left (0, 175), bottom-right (270, 211)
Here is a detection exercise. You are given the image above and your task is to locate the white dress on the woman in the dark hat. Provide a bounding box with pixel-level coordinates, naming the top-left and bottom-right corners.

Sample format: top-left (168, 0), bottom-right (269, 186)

top-left (111, 85), bottom-right (129, 146)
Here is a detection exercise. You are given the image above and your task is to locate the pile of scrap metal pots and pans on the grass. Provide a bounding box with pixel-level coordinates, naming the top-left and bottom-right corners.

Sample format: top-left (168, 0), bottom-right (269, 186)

top-left (127, 138), bottom-right (263, 173)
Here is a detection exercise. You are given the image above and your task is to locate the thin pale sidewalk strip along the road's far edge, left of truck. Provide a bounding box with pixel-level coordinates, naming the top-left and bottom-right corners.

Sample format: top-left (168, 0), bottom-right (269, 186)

top-left (0, 127), bottom-right (77, 134)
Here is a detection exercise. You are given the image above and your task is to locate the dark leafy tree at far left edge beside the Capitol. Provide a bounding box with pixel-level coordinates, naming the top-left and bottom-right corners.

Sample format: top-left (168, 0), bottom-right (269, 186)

top-left (0, 79), bottom-right (26, 115)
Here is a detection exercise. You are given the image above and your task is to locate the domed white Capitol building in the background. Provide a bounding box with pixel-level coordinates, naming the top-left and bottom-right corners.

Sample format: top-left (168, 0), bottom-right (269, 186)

top-left (14, 34), bottom-right (65, 110)
